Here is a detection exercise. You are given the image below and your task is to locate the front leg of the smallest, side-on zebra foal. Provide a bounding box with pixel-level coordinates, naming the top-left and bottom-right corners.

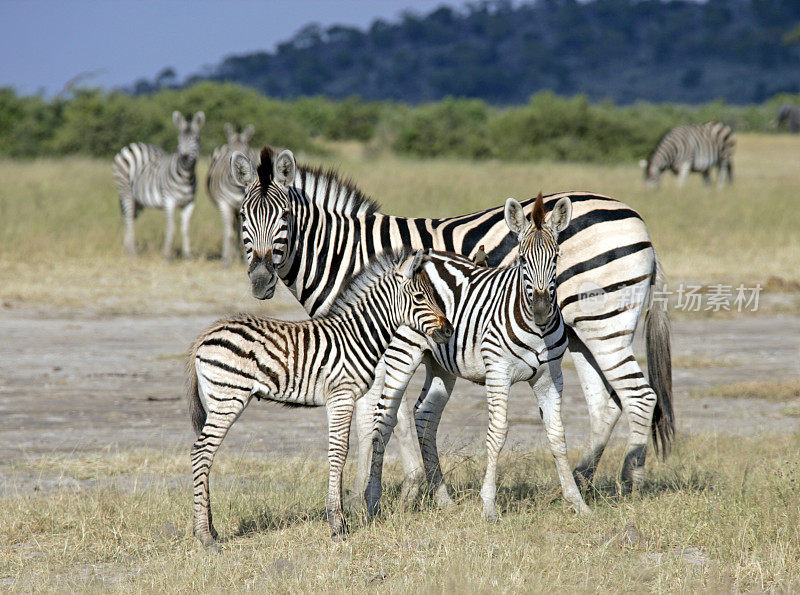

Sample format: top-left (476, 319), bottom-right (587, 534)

top-left (325, 390), bottom-right (356, 541)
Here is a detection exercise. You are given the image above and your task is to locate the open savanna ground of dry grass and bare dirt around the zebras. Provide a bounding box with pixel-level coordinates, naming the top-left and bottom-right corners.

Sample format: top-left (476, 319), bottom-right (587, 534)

top-left (0, 135), bottom-right (800, 592)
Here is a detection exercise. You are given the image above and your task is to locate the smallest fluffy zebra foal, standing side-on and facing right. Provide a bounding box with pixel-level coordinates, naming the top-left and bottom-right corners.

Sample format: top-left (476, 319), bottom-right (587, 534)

top-left (188, 250), bottom-right (453, 547)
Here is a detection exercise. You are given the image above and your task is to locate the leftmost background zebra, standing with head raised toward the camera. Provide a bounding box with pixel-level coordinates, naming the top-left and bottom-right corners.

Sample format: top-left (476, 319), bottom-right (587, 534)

top-left (114, 111), bottom-right (206, 258)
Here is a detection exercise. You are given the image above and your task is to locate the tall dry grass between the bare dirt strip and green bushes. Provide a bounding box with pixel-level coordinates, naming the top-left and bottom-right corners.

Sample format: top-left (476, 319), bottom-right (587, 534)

top-left (0, 135), bottom-right (800, 315)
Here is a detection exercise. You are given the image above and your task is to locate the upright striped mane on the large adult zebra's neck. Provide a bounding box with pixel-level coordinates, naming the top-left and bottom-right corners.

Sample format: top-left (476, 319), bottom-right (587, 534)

top-left (294, 164), bottom-right (380, 217)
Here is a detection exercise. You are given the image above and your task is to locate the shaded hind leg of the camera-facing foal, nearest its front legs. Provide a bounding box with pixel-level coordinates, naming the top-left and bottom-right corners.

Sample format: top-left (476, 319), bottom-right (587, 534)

top-left (414, 359), bottom-right (456, 508)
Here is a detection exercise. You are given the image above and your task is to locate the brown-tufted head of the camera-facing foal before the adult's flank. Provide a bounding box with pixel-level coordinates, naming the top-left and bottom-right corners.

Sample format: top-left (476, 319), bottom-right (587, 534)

top-left (505, 192), bottom-right (572, 327)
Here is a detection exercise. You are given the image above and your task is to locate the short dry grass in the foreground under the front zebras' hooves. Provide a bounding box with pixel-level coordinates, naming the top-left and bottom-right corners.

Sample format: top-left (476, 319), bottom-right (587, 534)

top-left (0, 436), bottom-right (800, 593)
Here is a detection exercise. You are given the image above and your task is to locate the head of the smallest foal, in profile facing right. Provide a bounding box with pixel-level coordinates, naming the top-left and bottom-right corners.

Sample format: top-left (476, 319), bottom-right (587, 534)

top-left (395, 250), bottom-right (453, 344)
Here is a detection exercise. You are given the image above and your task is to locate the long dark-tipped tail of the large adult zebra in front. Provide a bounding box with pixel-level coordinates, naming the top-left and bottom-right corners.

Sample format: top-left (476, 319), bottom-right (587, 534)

top-left (644, 258), bottom-right (675, 459)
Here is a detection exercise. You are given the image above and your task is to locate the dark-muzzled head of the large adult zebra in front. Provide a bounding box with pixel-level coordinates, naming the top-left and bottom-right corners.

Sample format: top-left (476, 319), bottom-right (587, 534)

top-left (231, 147), bottom-right (297, 300)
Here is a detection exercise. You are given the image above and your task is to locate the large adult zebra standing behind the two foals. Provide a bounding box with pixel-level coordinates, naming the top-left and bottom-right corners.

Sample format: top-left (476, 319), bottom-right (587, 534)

top-left (232, 147), bottom-right (674, 502)
